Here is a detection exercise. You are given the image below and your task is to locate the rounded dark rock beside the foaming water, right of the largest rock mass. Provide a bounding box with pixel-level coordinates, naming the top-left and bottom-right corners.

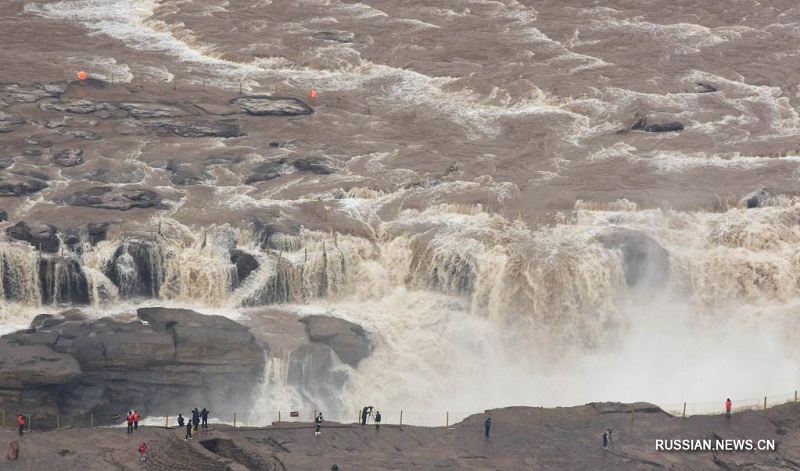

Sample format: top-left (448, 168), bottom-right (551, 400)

top-left (300, 316), bottom-right (374, 368)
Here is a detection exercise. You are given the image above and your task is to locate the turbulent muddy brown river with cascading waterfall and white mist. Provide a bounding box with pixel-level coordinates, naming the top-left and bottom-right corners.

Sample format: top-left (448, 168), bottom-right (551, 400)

top-left (0, 0), bottom-right (800, 420)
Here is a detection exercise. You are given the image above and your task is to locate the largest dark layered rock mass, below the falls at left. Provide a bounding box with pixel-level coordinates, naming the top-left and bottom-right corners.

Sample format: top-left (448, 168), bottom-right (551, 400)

top-left (0, 308), bottom-right (268, 428)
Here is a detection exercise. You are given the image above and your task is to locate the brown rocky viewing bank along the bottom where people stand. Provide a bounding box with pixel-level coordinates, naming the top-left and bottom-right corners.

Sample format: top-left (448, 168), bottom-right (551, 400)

top-left (0, 403), bottom-right (800, 471)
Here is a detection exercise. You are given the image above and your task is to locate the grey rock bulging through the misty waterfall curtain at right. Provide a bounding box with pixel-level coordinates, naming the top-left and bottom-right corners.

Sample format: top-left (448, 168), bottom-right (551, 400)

top-left (597, 227), bottom-right (670, 288)
